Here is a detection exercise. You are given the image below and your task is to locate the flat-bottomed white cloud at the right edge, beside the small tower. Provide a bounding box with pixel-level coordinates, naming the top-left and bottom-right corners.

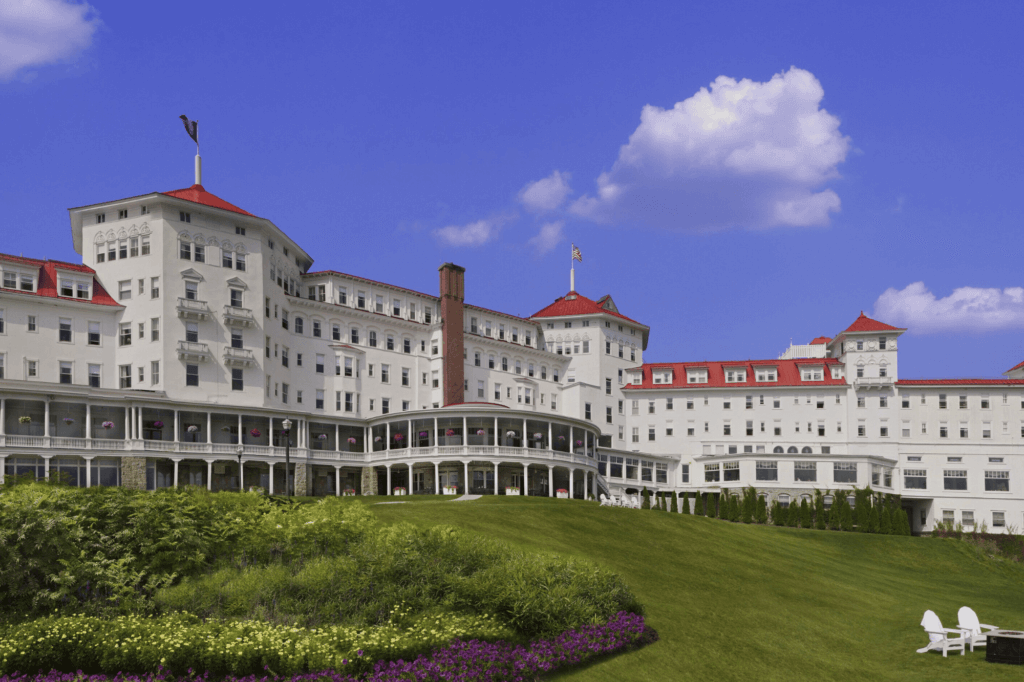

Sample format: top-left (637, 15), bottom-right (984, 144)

top-left (874, 282), bottom-right (1024, 334)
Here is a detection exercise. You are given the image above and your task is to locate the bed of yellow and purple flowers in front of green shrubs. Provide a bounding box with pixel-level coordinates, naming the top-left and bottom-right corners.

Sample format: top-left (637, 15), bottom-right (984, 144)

top-left (0, 611), bottom-right (657, 682)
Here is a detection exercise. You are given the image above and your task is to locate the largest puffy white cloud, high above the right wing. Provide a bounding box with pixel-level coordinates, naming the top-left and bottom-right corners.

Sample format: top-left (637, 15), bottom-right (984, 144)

top-left (571, 68), bottom-right (850, 231)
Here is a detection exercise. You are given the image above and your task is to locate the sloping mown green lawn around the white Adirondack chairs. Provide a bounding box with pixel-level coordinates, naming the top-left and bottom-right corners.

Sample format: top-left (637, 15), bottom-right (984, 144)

top-left (359, 497), bottom-right (1024, 682)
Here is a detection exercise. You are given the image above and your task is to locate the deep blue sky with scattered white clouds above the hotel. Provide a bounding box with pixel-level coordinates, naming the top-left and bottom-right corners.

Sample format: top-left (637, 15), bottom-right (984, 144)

top-left (0, 0), bottom-right (1024, 378)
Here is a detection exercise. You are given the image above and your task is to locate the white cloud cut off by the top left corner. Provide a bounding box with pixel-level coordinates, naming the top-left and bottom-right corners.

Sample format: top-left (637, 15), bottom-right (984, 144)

top-left (0, 0), bottom-right (99, 81)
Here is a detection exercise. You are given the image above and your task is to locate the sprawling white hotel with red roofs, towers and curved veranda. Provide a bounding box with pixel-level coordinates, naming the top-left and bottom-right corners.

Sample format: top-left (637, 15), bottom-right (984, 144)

top-left (0, 173), bottom-right (1024, 532)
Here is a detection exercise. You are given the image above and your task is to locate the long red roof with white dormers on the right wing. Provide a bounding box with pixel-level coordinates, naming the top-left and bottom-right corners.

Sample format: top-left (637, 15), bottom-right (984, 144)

top-left (624, 357), bottom-right (847, 390)
